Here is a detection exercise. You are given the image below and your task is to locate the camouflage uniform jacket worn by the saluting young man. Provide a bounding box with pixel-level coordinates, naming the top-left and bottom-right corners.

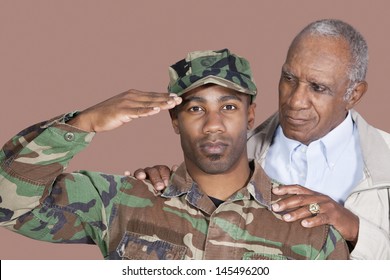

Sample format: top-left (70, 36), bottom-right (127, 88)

top-left (0, 114), bottom-right (349, 259)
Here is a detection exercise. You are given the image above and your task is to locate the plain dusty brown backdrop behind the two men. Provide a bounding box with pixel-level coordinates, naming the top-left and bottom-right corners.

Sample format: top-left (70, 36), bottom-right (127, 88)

top-left (0, 0), bottom-right (390, 259)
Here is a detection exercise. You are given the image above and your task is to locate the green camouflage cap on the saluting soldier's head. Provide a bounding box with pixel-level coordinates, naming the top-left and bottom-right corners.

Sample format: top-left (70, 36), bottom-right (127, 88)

top-left (168, 49), bottom-right (257, 101)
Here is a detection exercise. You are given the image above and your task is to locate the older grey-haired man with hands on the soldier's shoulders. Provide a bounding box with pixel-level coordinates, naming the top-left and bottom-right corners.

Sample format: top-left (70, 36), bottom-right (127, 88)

top-left (136, 20), bottom-right (390, 259)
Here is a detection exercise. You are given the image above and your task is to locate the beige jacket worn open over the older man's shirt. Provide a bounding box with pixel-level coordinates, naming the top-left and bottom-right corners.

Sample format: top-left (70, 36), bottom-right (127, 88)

top-left (248, 110), bottom-right (390, 260)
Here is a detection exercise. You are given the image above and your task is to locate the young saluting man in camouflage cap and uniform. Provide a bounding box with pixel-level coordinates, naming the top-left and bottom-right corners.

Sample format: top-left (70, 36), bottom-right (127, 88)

top-left (0, 50), bottom-right (349, 259)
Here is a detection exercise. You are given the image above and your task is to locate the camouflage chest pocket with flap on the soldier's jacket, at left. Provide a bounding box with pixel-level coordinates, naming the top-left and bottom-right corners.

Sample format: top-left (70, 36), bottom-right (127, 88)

top-left (116, 231), bottom-right (187, 260)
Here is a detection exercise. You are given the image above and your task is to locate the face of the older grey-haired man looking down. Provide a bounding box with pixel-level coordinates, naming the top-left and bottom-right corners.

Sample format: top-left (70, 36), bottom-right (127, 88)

top-left (279, 36), bottom-right (351, 145)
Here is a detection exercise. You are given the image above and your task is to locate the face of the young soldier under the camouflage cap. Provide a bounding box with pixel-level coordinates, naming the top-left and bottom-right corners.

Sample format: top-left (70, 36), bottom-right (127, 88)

top-left (172, 85), bottom-right (255, 174)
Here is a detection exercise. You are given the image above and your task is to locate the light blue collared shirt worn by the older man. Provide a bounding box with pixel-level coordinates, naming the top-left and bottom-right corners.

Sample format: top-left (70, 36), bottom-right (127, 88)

top-left (264, 112), bottom-right (364, 204)
